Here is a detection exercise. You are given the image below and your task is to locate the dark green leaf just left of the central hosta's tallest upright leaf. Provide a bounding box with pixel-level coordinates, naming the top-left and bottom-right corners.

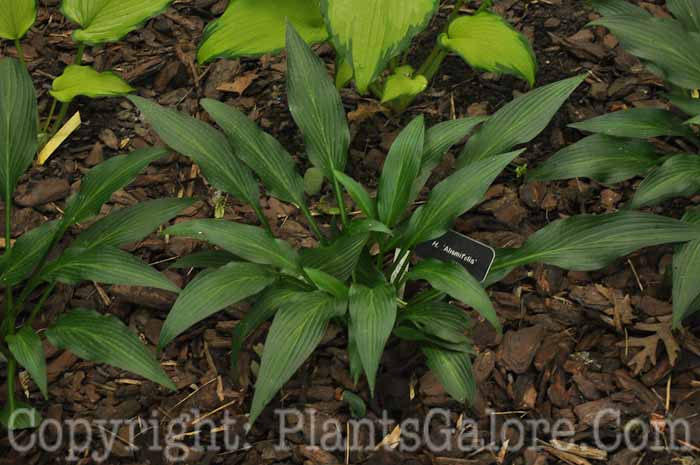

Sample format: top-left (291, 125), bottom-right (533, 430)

top-left (201, 99), bottom-right (304, 205)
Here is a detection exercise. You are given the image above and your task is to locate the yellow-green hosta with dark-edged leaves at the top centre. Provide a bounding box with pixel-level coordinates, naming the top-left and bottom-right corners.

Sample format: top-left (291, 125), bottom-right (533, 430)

top-left (197, 0), bottom-right (537, 110)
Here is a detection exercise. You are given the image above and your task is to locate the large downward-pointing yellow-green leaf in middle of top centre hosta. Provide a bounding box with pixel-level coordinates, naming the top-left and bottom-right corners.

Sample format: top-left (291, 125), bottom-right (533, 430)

top-left (321, 0), bottom-right (439, 94)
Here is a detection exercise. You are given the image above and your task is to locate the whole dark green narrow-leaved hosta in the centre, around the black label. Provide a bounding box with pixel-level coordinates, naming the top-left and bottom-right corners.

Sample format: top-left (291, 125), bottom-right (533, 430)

top-left (130, 27), bottom-right (698, 421)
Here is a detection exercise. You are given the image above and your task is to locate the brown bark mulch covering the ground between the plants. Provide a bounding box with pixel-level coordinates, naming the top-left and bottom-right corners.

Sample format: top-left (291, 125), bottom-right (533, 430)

top-left (0, 0), bottom-right (700, 465)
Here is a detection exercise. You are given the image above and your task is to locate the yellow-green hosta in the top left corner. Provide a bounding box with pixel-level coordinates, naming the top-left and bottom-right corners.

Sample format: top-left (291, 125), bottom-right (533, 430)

top-left (0, 0), bottom-right (172, 142)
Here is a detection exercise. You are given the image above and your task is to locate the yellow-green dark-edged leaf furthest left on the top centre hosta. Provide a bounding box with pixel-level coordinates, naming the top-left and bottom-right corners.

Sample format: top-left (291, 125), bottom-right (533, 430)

top-left (197, 0), bottom-right (328, 63)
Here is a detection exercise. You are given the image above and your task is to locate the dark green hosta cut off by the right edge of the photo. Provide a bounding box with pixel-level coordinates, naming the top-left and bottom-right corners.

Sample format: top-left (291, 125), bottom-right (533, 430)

top-left (529, 0), bottom-right (700, 326)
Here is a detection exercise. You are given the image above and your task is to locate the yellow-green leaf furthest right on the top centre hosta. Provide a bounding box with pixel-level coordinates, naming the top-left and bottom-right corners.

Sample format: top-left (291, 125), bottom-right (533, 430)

top-left (438, 11), bottom-right (537, 86)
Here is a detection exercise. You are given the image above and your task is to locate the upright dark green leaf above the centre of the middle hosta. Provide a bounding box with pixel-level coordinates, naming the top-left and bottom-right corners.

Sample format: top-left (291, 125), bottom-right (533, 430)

top-left (377, 116), bottom-right (425, 227)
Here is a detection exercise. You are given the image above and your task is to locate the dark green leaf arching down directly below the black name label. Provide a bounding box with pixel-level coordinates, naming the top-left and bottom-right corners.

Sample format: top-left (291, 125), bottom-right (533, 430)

top-left (408, 260), bottom-right (501, 331)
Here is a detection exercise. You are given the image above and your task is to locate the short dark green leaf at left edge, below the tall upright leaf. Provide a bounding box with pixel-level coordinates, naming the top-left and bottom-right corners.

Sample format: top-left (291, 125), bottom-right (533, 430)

top-left (0, 220), bottom-right (59, 286)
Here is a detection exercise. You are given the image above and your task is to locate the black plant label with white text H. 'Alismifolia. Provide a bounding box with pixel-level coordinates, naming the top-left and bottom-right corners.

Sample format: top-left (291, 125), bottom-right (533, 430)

top-left (416, 231), bottom-right (496, 281)
